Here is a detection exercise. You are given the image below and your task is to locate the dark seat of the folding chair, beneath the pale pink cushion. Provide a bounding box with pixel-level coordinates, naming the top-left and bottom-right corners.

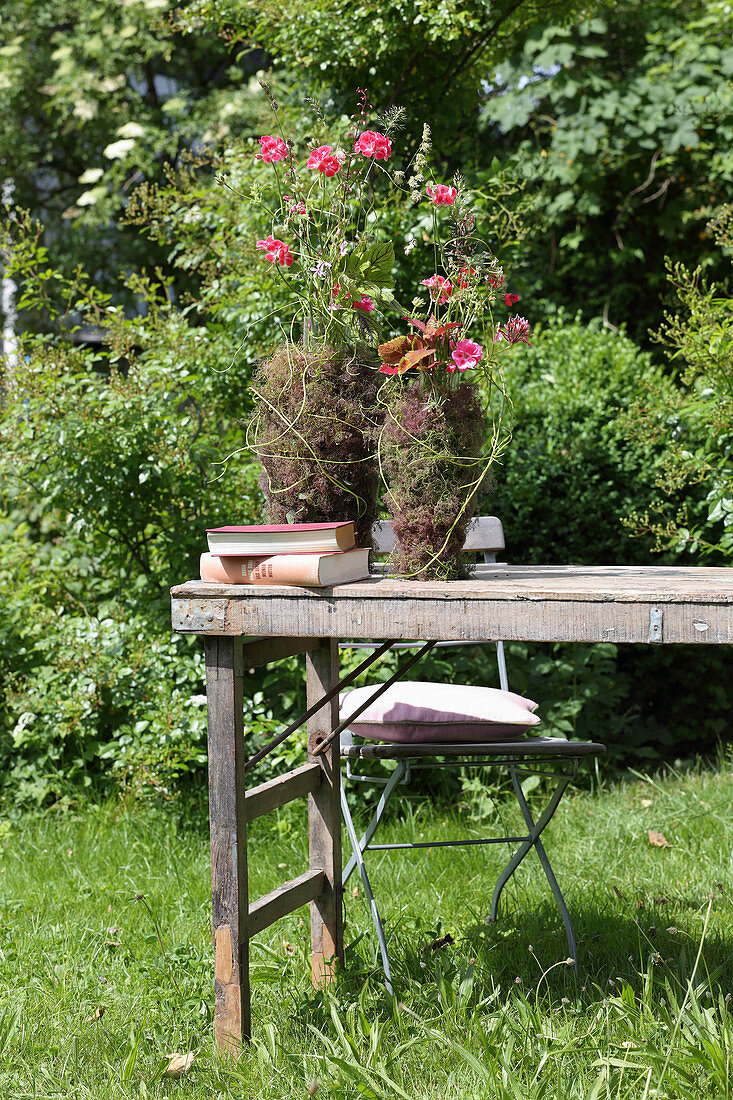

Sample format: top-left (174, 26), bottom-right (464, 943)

top-left (341, 737), bottom-right (605, 760)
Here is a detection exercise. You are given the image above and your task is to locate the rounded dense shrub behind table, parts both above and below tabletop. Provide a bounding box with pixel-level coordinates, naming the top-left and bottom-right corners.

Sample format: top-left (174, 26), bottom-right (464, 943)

top-left (482, 320), bottom-right (731, 763)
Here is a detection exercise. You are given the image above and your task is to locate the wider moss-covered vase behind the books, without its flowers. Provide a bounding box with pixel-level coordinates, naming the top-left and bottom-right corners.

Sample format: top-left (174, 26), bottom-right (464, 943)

top-left (251, 344), bottom-right (380, 547)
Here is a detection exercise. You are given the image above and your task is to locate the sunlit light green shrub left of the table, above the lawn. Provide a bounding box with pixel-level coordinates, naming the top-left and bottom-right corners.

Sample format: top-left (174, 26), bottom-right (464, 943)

top-left (0, 210), bottom-right (268, 802)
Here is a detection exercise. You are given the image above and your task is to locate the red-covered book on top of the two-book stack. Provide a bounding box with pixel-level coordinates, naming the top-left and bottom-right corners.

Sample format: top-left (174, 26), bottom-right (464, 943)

top-left (206, 520), bottom-right (357, 558)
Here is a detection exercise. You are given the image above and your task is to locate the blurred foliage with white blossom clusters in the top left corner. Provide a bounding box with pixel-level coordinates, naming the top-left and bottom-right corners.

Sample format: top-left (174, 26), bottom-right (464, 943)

top-left (0, 0), bottom-right (266, 292)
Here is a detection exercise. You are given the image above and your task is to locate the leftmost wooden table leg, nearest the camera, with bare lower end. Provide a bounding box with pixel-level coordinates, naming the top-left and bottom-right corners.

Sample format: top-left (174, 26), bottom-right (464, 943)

top-left (206, 637), bottom-right (251, 1054)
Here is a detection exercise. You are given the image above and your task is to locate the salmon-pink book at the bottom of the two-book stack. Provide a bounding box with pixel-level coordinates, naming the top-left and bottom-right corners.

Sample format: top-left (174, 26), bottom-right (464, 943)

top-left (200, 548), bottom-right (370, 589)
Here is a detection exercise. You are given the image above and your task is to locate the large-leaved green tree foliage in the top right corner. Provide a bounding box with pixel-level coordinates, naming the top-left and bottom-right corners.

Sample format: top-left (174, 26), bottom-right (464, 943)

top-left (482, 0), bottom-right (733, 343)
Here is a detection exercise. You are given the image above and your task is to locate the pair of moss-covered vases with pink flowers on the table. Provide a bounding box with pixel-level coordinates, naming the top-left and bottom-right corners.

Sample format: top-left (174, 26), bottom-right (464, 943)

top-left (231, 84), bottom-right (529, 578)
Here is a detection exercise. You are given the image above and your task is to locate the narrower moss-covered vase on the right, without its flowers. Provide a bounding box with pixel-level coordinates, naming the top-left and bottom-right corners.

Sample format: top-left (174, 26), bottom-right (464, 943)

top-left (381, 383), bottom-right (485, 580)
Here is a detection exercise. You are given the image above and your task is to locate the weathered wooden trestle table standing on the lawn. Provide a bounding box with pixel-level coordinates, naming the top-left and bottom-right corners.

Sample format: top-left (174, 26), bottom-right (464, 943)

top-left (171, 565), bottom-right (733, 1049)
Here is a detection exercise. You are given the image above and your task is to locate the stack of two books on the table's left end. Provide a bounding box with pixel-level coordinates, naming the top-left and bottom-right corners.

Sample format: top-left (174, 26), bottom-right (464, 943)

top-left (200, 521), bottom-right (369, 589)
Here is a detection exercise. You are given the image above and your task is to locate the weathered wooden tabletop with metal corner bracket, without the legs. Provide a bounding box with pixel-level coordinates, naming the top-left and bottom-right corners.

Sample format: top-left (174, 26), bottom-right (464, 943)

top-left (171, 565), bottom-right (733, 645)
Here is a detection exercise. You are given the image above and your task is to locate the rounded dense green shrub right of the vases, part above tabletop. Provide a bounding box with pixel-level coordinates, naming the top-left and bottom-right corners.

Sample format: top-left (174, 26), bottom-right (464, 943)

top-left (483, 320), bottom-right (674, 564)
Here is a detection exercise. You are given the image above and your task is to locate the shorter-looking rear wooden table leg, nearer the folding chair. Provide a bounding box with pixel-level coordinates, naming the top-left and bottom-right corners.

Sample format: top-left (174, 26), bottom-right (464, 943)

top-left (306, 638), bottom-right (343, 986)
